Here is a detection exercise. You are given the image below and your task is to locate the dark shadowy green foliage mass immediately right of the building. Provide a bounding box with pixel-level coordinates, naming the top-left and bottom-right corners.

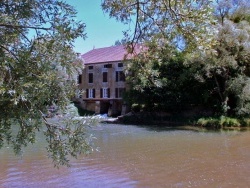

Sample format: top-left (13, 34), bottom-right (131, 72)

top-left (125, 48), bottom-right (215, 112)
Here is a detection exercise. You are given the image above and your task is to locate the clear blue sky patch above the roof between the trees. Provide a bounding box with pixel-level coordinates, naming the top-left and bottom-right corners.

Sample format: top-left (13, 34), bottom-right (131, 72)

top-left (66, 0), bottom-right (128, 54)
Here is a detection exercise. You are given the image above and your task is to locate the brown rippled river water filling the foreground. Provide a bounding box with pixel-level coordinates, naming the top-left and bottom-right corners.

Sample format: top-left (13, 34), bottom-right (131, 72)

top-left (0, 124), bottom-right (250, 188)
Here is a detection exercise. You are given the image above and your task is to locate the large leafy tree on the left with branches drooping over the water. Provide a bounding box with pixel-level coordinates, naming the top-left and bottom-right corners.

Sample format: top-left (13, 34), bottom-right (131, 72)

top-left (0, 0), bottom-right (93, 165)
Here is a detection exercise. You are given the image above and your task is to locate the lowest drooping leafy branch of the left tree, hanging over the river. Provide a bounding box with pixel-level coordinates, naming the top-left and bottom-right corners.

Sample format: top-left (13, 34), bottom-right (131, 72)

top-left (44, 116), bottom-right (95, 167)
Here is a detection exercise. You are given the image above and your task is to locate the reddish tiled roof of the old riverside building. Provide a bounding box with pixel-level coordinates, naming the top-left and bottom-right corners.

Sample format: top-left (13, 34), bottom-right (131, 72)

top-left (81, 45), bottom-right (142, 64)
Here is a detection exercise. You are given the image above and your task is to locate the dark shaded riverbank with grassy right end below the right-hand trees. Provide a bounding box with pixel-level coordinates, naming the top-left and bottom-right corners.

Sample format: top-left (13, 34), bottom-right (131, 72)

top-left (102, 112), bottom-right (250, 129)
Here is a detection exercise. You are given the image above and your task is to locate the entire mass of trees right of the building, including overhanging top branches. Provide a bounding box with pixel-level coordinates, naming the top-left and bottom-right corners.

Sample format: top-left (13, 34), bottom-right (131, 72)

top-left (103, 0), bottom-right (250, 117)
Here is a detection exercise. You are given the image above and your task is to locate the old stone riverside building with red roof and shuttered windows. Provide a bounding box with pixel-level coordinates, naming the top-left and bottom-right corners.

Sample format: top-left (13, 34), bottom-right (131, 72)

top-left (78, 46), bottom-right (136, 116)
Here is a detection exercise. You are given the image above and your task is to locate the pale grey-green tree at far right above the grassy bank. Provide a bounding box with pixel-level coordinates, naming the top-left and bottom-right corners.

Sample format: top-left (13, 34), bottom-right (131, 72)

top-left (190, 0), bottom-right (250, 116)
